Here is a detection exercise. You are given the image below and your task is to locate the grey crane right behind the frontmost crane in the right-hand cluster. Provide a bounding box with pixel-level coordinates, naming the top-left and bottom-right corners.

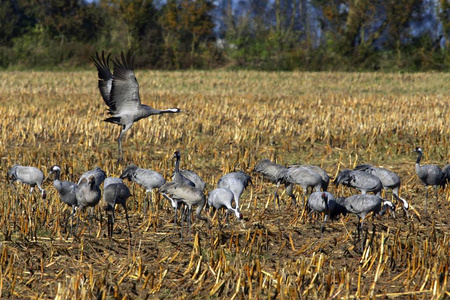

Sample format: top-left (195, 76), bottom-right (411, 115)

top-left (333, 170), bottom-right (383, 196)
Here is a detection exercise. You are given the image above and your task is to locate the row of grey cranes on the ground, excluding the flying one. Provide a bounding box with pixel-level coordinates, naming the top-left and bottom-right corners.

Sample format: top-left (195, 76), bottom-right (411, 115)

top-left (8, 147), bottom-right (450, 245)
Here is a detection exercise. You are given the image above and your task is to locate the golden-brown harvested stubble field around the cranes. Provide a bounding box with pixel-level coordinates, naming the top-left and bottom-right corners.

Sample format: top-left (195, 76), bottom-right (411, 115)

top-left (0, 71), bottom-right (450, 299)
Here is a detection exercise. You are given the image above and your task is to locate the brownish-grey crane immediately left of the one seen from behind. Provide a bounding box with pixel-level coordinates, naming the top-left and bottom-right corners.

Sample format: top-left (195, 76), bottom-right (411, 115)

top-left (75, 174), bottom-right (102, 231)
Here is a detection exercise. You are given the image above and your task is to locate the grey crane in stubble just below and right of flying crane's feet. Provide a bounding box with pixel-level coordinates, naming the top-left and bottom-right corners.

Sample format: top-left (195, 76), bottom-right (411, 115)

top-left (120, 164), bottom-right (166, 208)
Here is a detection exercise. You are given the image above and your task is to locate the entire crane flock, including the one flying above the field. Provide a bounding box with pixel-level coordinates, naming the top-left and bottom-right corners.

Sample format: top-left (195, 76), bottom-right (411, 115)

top-left (7, 52), bottom-right (450, 248)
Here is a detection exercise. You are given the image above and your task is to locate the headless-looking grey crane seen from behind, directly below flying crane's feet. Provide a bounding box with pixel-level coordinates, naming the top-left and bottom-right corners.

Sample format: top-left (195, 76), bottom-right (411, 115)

top-left (101, 182), bottom-right (131, 238)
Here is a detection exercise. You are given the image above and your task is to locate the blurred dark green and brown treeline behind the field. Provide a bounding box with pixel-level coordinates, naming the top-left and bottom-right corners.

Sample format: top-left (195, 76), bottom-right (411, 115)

top-left (0, 0), bottom-right (450, 71)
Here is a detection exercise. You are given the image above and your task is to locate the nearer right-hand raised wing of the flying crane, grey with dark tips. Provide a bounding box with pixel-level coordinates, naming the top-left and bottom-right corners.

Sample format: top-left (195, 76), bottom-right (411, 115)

top-left (109, 52), bottom-right (141, 112)
